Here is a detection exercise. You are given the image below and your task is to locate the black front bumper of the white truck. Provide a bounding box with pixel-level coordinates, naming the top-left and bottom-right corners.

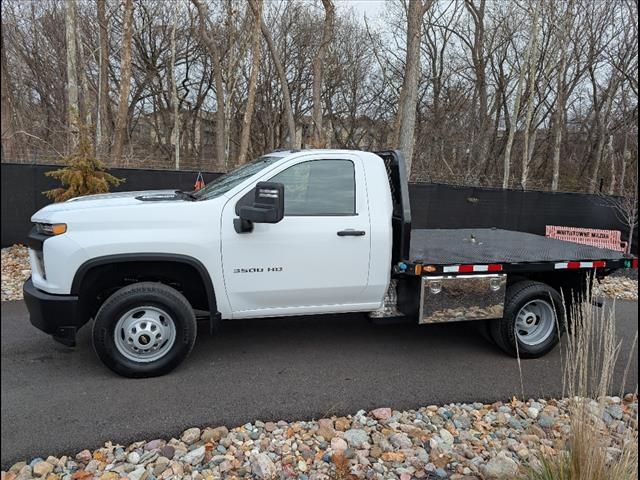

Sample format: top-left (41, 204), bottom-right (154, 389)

top-left (22, 278), bottom-right (81, 347)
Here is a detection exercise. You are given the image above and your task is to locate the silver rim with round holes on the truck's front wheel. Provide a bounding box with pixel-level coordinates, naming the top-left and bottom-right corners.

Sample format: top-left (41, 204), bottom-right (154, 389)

top-left (113, 306), bottom-right (176, 363)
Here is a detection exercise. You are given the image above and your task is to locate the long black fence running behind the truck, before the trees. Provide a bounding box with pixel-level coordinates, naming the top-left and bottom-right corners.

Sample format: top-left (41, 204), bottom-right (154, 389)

top-left (2, 163), bottom-right (638, 252)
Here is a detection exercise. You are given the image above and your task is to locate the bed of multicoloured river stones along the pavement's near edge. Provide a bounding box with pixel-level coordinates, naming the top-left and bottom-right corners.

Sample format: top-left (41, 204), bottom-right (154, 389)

top-left (2, 394), bottom-right (638, 480)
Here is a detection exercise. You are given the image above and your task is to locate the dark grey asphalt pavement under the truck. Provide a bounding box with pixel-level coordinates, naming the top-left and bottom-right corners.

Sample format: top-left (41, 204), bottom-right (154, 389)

top-left (1, 301), bottom-right (638, 468)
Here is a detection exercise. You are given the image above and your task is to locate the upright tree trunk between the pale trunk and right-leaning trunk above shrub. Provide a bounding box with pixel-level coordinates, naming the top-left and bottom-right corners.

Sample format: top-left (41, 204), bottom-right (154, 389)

top-left (96, 0), bottom-right (109, 156)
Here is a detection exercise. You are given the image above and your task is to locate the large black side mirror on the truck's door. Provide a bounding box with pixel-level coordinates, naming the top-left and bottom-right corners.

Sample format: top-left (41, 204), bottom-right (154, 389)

top-left (233, 182), bottom-right (284, 233)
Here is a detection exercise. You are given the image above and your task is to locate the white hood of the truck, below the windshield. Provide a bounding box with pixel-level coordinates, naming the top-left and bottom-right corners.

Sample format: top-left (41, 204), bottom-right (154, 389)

top-left (32, 190), bottom-right (186, 221)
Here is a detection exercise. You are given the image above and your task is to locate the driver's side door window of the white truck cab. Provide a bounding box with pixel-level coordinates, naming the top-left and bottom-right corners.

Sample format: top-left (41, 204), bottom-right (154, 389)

top-left (270, 160), bottom-right (356, 216)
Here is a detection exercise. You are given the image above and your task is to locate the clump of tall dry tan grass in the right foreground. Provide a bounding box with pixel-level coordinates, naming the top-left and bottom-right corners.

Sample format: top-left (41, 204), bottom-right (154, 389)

top-left (524, 282), bottom-right (638, 480)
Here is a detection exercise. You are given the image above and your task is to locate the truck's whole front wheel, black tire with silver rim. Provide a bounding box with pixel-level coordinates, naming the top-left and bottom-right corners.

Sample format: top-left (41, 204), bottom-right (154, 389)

top-left (92, 282), bottom-right (197, 378)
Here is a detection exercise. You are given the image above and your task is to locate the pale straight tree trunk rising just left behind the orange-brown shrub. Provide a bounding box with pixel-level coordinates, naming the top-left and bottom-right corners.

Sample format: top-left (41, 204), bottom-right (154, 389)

top-left (64, 0), bottom-right (80, 150)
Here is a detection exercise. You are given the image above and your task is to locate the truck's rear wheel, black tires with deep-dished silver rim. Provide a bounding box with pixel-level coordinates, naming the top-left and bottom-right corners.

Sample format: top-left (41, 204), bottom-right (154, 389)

top-left (490, 280), bottom-right (565, 358)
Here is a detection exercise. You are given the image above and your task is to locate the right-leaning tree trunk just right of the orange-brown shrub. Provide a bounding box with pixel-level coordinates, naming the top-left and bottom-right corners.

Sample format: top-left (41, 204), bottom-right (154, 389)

top-left (112, 0), bottom-right (133, 165)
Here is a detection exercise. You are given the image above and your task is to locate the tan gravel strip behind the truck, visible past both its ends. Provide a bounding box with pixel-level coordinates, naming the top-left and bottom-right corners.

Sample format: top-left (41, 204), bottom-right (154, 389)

top-left (2, 245), bottom-right (638, 302)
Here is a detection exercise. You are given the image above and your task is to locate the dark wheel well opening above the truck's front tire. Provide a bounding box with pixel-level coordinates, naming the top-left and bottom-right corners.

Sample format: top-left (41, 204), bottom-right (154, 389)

top-left (71, 259), bottom-right (217, 322)
